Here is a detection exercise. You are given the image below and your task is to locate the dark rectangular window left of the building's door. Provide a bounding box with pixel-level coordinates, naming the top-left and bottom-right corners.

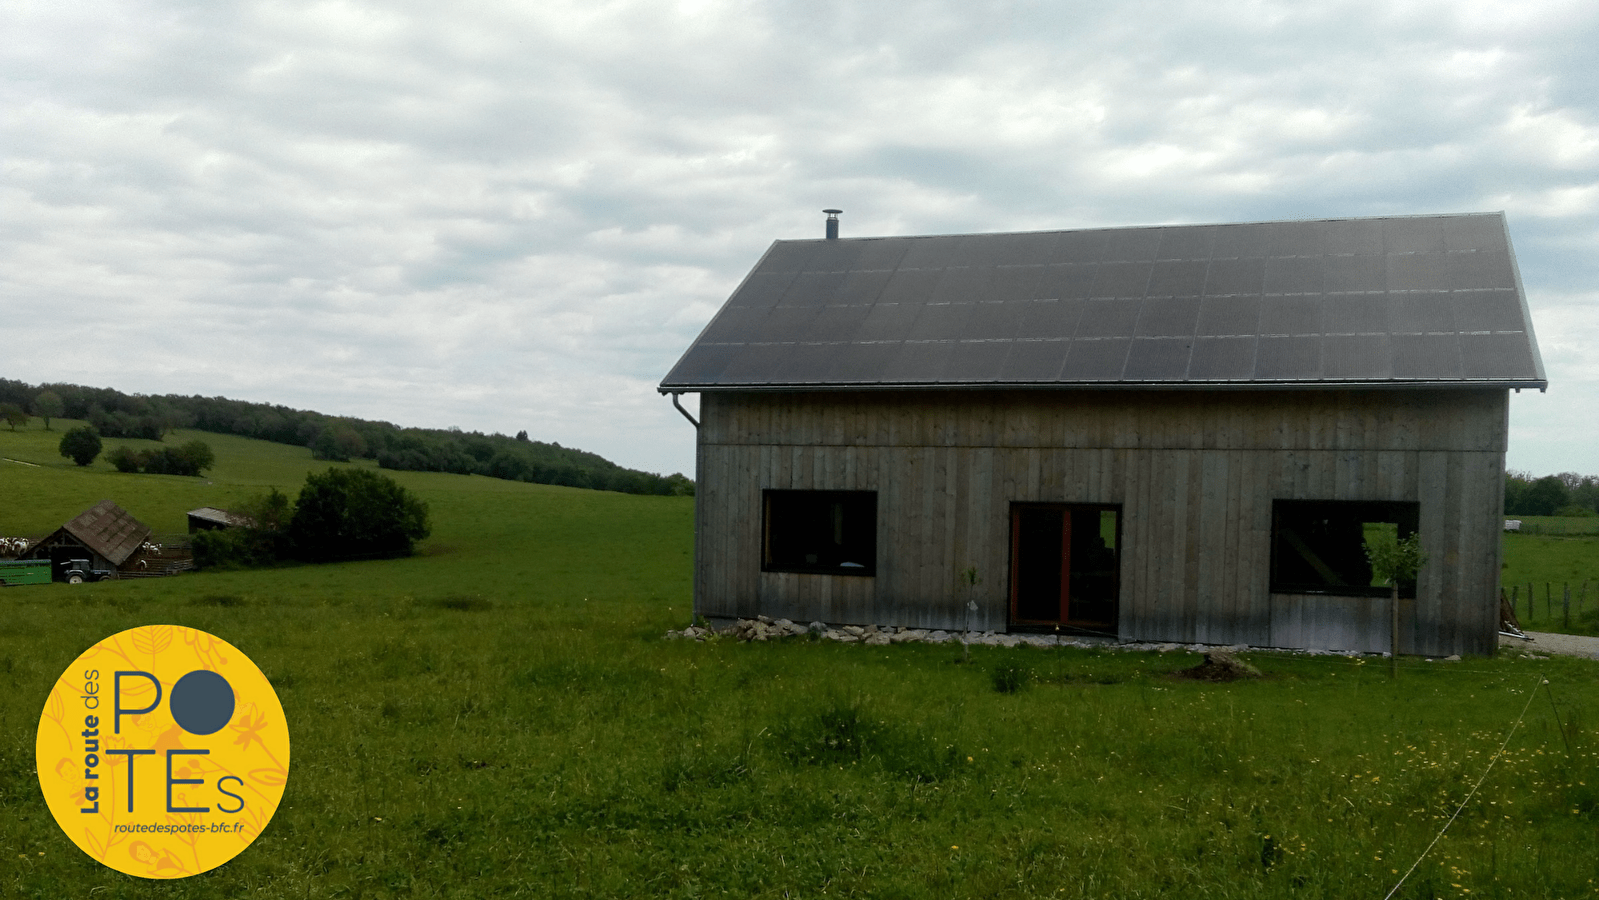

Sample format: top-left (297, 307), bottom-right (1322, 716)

top-left (761, 491), bottom-right (878, 575)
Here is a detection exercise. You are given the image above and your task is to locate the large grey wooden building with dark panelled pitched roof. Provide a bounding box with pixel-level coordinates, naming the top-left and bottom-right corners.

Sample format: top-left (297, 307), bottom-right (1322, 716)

top-left (660, 213), bottom-right (1548, 655)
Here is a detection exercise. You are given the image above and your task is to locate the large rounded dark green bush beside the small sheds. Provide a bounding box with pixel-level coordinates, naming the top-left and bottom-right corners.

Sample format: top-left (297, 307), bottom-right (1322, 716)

top-left (289, 468), bottom-right (430, 561)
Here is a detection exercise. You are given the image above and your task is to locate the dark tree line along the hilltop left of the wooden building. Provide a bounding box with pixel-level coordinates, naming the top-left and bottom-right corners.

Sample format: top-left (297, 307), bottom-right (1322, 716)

top-left (0, 379), bottom-right (694, 496)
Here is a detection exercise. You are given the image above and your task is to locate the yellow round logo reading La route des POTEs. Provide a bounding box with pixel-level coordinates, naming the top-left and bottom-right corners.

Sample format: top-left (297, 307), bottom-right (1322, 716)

top-left (35, 625), bottom-right (289, 878)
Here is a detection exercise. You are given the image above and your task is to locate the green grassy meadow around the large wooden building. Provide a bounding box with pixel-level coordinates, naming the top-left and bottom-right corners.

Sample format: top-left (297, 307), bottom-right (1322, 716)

top-left (0, 420), bottom-right (1599, 900)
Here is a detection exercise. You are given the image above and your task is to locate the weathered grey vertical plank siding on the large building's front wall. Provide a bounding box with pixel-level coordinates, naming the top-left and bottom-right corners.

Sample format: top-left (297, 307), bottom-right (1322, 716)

top-left (696, 390), bottom-right (1508, 655)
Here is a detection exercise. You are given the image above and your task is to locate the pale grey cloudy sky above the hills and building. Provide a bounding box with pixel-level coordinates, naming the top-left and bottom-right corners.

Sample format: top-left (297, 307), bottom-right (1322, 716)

top-left (0, 0), bottom-right (1599, 475)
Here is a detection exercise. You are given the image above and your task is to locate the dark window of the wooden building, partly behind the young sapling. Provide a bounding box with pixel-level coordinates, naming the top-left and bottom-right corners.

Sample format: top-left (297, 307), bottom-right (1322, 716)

top-left (1271, 500), bottom-right (1422, 598)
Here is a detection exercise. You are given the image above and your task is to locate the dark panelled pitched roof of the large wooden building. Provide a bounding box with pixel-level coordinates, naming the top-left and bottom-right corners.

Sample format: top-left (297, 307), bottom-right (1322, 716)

top-left (659, 213), bottom-right (1548, 393)
